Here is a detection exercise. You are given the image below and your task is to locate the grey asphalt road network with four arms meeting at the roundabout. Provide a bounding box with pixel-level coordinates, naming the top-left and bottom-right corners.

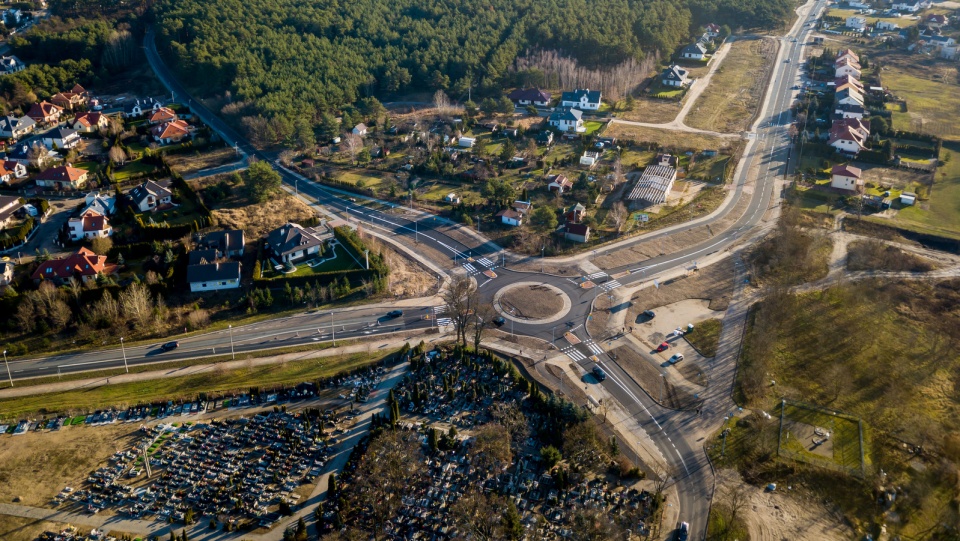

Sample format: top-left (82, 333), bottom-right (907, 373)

top-left (0, 15), bottom-right (825, 539)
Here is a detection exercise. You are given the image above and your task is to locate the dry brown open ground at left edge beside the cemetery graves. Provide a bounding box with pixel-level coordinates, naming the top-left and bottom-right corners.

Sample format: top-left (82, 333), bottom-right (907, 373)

top-left (0, 424), bottom-right (137, 506)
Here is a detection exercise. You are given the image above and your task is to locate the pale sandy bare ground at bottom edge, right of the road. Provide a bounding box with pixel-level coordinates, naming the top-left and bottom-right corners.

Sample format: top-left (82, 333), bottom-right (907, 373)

top-left (715, 470), bottom-right (854, 541)
